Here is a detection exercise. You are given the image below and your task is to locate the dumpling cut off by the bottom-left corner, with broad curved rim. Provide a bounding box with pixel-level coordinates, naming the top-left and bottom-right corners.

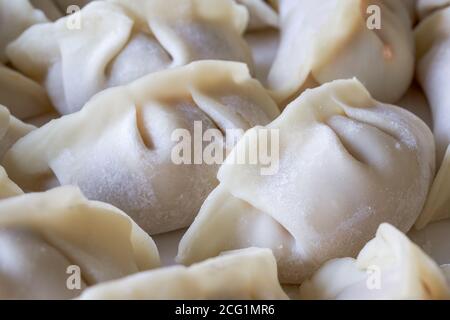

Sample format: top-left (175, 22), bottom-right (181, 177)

top-left (0, 187), bottom-right (159, 299)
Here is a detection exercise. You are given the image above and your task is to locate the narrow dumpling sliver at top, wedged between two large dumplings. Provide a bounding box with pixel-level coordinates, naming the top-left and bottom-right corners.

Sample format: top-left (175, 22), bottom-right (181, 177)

top-left (237, 0), bottom-right (280, 84)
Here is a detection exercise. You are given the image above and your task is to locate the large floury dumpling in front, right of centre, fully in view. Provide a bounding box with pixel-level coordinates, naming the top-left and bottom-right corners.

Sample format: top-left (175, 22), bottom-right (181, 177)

top-left (177, 80), bottom-right (435, 283)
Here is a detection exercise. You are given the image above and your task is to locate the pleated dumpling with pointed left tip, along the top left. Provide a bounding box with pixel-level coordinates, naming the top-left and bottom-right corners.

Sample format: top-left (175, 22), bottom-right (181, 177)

top-left (7, 0), bottom-right (252, 114)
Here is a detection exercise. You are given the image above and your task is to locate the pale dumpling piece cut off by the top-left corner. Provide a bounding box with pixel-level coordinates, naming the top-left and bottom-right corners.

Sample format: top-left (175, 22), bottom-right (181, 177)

top-left (0, 0), bottom-right (48, 63)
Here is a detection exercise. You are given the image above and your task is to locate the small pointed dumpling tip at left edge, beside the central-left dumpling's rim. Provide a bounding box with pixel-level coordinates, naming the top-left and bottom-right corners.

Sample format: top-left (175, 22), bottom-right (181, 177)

top-left (0, 105), bottom-right (36, 159)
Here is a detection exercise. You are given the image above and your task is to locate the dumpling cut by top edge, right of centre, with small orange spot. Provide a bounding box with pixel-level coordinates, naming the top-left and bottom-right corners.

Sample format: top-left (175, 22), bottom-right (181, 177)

top-left (268, 0), bottom-right (414, 105)
